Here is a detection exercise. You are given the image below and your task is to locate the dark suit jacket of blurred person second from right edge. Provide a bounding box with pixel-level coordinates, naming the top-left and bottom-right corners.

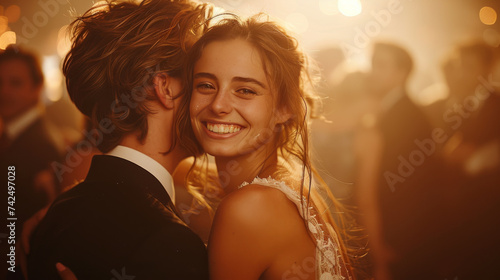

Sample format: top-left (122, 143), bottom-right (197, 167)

top-left (378, 94), bottom-right (442, 279)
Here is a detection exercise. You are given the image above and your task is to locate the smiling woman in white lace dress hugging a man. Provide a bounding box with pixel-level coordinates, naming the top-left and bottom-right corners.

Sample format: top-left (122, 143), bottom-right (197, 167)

top-left (177, 14), bottom-right (360, 279)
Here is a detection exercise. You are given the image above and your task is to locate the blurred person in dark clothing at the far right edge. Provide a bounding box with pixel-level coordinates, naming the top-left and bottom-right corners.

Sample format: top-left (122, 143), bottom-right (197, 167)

top-left (427, 40), bottom-right (500, 279)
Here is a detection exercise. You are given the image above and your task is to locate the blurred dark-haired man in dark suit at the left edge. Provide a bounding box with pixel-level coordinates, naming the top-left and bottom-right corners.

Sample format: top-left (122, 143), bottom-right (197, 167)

top-left (0, 45), bottom-right (61, 279)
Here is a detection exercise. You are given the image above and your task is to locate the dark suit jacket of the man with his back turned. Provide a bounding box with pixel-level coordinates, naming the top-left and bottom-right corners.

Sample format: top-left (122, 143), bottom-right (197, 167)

top-left (28, 156), bottom-right (208, 280)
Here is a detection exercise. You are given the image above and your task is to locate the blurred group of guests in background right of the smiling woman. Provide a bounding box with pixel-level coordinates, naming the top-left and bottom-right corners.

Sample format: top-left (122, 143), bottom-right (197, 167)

top-left (313, 40), bottom-right (500, 279)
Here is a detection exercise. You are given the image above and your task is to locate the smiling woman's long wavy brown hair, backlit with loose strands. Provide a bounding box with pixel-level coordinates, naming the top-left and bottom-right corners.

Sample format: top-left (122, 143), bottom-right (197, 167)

top-left (176, 15), bottom-right (364, 275)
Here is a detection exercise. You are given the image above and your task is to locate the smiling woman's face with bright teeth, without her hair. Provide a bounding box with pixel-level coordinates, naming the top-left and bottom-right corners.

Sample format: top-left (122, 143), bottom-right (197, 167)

top-left (191, 39), bottom-right (287, 159)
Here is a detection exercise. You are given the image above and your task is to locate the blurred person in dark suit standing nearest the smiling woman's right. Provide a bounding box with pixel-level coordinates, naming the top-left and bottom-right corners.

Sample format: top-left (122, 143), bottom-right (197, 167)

top-left (354, 43), bottom-right (441, 279)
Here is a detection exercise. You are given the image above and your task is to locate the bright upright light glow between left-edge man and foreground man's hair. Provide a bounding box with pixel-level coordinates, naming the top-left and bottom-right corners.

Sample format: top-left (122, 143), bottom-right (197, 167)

top-left (42, 55), bottom-right (63, 102)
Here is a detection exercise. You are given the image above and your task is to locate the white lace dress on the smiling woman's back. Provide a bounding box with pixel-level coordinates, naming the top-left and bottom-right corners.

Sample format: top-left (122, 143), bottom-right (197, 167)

top-left (239, 177), bottom-right (352, 280)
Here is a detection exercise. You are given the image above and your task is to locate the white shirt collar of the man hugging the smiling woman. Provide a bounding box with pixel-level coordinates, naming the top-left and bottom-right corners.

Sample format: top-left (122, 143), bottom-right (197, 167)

top-left (106, 145), bottom-right (175, 204)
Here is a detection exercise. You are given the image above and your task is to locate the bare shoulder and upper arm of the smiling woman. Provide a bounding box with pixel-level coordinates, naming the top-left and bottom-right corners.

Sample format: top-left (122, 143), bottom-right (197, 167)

top-left (208, 184), bottom-right (314, 279)
